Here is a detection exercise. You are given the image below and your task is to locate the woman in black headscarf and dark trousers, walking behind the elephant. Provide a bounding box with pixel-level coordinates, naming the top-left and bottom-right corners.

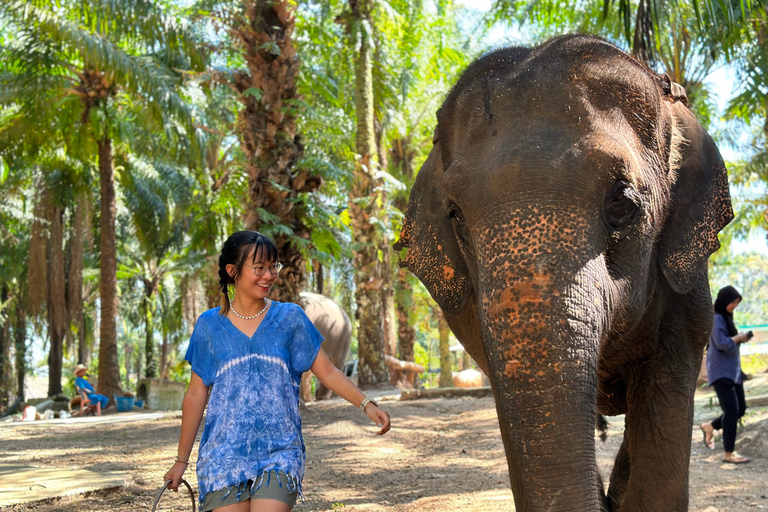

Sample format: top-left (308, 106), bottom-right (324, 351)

top-left (701, 286), bottom-right (749, 464)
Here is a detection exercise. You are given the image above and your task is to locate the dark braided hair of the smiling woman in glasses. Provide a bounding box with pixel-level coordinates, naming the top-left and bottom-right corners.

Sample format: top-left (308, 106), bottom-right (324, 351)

top-left (219, 231), bottom-right (277, 315)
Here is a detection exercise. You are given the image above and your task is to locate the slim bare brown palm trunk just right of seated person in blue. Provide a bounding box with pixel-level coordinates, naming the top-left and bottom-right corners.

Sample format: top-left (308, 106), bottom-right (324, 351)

top-left (98, 136), bottom-right (122, 400)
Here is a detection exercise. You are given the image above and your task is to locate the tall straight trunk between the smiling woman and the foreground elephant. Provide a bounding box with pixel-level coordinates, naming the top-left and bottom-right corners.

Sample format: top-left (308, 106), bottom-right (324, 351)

top-left (349, 0), bottom-right (389, 385)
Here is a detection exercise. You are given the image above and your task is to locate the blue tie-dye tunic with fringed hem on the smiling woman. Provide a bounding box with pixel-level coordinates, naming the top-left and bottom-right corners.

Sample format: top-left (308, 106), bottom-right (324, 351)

top-left (186, 301), bottom-right (323, 503)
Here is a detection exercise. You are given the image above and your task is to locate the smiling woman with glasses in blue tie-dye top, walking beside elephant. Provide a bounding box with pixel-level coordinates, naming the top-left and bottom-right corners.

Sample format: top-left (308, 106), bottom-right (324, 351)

top-left (164, 231), bottom-right (390, 512)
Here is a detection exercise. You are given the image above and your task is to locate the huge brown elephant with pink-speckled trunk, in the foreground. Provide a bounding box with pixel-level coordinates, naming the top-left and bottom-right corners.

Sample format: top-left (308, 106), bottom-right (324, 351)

top-left (394, 35), bottom-right (733, 512)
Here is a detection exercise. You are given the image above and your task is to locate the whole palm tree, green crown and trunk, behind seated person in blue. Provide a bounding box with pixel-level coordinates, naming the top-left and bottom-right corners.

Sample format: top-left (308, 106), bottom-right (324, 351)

top-left (2, 0), bottom-right (203, 396)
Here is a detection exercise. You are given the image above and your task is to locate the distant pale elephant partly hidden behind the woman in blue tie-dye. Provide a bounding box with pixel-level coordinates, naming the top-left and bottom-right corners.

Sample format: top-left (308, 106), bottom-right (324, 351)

top-left (299, 292), bottom-right (352, 402)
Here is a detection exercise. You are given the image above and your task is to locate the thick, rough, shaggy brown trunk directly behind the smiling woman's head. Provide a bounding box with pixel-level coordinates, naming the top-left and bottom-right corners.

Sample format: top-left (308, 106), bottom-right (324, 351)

top-left (230, 0), bottom-right (321, 302)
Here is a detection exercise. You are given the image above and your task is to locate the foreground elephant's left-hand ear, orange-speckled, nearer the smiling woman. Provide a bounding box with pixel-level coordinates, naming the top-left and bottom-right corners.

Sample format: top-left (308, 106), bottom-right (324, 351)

top-left (394, 141), bottom-right (471, 314)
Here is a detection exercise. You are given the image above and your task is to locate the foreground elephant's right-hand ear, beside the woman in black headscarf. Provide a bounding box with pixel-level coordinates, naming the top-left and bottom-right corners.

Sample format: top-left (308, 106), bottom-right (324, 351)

top-left (659, 102), bottom-right (733, 294)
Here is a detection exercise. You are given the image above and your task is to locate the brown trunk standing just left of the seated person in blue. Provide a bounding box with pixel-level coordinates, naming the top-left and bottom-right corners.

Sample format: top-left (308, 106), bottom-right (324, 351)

top-left (48, 206), bottom-right (69, 396)
